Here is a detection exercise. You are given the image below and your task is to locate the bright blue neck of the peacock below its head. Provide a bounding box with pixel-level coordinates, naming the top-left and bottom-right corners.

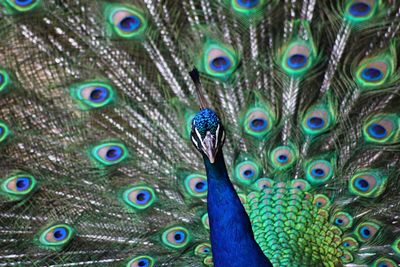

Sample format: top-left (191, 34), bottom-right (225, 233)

top-left (204, 151), bottom-right (272, 267)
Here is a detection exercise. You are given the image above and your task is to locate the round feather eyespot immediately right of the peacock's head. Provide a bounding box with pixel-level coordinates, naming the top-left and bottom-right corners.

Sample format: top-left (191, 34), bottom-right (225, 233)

top-left (244, 108), bottom-right (274, 137)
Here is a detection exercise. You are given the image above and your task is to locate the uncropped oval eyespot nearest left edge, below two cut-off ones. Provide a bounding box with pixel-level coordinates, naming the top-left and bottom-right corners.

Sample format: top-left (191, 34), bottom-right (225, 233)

top-left (1, 173), bottom-right (36, 198)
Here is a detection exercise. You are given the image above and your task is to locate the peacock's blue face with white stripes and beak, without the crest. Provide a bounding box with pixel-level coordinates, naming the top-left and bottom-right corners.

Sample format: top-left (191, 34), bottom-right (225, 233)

top-left (191, 108), bottom-right (225, 163)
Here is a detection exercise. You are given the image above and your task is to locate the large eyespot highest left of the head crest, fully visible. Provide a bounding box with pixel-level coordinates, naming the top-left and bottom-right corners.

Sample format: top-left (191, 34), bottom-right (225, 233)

top-left (106, 4), bottom-right (147, 39)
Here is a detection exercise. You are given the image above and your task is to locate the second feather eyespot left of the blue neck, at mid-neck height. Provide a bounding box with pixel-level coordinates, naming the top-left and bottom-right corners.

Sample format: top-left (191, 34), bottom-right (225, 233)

top-left (123, 186), bottom-right (156, 210)
